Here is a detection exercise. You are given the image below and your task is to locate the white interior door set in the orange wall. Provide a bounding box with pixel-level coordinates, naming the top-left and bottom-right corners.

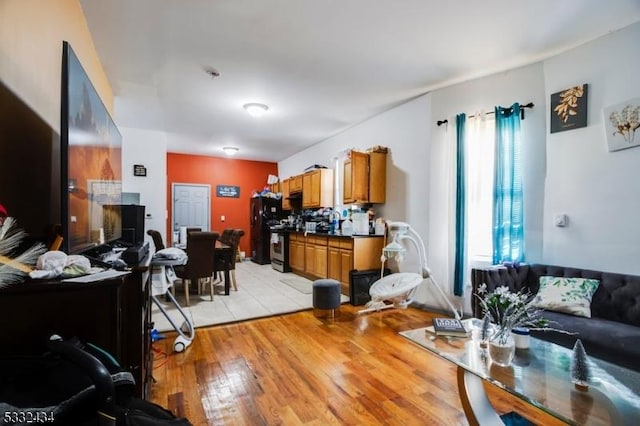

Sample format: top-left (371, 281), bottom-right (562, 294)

top-left (171, 183), bottom-right (211, 238)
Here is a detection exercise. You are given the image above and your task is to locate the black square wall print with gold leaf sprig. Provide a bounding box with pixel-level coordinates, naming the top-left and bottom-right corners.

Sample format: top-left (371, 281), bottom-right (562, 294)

top-left (551, 84), bottom-right (588, 133)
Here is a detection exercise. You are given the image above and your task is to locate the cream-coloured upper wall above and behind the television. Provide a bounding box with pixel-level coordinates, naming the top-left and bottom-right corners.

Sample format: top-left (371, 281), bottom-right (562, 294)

top-left (0, 0), bottom-right (118, 133)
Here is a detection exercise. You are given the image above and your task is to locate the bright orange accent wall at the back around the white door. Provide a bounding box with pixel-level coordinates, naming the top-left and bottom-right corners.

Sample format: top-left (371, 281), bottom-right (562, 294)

top-left (166, 153), bottom-right (278, 256)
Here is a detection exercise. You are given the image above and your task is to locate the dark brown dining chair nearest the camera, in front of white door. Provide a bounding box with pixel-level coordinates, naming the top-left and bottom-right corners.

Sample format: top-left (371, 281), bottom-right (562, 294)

top-left (174, 231), bottom-right (219, 306)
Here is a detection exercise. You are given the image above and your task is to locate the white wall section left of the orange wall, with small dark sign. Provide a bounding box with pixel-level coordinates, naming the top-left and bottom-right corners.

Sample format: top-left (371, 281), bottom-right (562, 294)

top-left (116, 125), bottom-right (168, 248)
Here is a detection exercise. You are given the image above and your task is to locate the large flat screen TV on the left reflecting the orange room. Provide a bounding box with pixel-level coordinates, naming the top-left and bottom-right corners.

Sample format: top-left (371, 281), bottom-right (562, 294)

top-left (60, 41), bottom-right (122, 254)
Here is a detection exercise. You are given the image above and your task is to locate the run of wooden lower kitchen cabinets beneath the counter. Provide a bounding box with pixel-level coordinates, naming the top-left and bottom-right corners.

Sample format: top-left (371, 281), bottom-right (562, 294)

top-left (289, 231), bottom-right (384, 295)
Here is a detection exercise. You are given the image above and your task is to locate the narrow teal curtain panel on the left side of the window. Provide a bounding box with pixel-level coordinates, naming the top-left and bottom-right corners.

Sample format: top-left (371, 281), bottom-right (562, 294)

top-left (453, 114), bottom-right (467, 296)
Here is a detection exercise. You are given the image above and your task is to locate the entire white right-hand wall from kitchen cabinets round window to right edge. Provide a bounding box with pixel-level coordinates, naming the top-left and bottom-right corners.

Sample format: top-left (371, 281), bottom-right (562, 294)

top-left (279, 24), bottom-right (640, 311)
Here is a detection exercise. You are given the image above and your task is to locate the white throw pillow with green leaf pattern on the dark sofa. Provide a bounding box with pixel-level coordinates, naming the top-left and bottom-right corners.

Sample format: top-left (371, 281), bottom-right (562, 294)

top-left (534, 276), bottom-right (600, 318)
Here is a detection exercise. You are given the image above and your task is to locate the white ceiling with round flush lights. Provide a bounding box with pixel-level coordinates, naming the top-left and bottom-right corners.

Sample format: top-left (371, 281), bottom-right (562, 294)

top-left (80, 0), bottom-right (640, 161)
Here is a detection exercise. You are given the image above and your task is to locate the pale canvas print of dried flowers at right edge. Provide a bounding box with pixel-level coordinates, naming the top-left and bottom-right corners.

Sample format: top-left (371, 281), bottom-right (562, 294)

top-left (602, 98), bottom-right (640, 151)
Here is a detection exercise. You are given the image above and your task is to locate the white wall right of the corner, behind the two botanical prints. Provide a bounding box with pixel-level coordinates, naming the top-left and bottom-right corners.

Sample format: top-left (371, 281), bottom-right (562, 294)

top-left (544, 24), bottom-right (640, 274)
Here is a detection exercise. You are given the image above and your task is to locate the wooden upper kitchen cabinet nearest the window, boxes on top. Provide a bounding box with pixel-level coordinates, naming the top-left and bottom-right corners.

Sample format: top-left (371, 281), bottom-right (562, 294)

top-left (342, 151), bottom-right (387, 204)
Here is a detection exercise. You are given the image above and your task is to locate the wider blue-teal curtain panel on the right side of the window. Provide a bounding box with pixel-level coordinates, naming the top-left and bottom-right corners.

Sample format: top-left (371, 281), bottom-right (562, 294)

top-left (493, 103), bottom-right (524, 264)
